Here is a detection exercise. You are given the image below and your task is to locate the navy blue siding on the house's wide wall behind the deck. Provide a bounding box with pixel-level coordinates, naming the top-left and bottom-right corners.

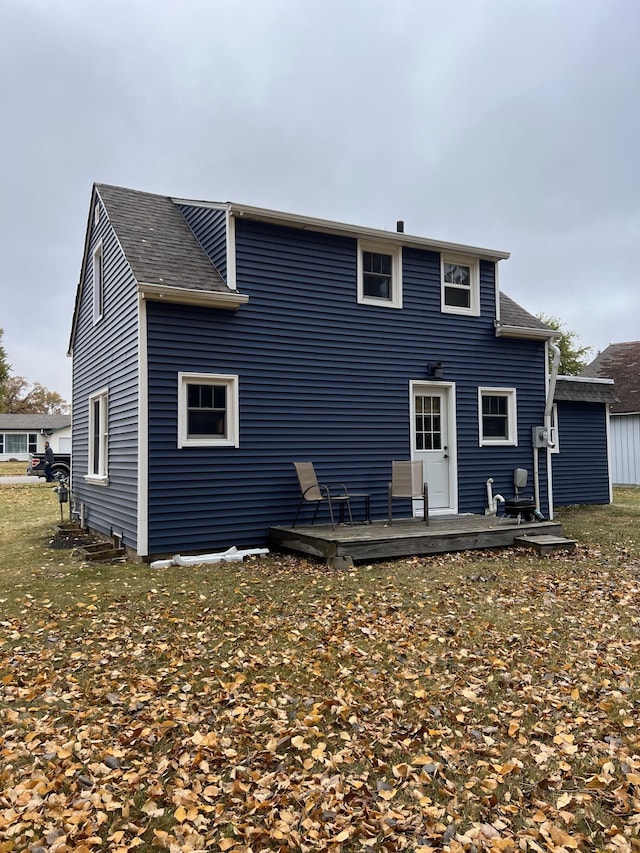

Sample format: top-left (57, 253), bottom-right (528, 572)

top-left (148, 220), bottom-right (546, 553)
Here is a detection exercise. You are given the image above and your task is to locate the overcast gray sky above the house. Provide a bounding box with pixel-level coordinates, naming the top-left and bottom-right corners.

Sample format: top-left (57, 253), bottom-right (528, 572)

top-left (0, 0), bottom-right (640, 401)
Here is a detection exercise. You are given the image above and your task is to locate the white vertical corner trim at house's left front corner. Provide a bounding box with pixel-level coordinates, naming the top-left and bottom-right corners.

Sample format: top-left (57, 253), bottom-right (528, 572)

top-left (136, 299), bottom-right (149, 557)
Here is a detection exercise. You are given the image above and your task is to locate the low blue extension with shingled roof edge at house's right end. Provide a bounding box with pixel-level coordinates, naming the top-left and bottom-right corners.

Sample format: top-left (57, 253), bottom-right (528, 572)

top-left (552, 376), bottom-right (617, 506)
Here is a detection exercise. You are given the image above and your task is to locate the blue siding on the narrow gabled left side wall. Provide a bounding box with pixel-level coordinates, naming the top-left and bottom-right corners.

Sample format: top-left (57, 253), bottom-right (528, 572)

top-left (72, 197), bottom-right (138, 549)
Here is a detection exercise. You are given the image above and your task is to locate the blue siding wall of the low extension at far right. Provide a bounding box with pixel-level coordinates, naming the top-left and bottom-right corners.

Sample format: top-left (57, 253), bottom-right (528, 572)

top-left (552, 401), bottom-right (610, 506)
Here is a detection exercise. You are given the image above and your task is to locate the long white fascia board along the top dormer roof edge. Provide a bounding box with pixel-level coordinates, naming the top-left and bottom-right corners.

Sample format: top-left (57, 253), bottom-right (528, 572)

top-left (172, 198), bottom-right (511, 261)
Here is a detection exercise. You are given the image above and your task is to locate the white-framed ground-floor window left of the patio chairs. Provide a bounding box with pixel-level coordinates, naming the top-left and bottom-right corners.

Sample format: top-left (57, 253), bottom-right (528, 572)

top-left (178, 373), bottom-right (239, 447)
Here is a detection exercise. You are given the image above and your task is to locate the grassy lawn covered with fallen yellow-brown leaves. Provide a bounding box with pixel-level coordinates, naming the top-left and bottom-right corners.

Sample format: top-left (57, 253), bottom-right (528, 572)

top-left (0, 484), bottom-right (640, 853)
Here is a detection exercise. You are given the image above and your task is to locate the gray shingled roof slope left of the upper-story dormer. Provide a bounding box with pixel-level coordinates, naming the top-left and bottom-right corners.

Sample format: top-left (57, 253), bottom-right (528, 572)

top-left (96, 184), bottom-right (229, 293)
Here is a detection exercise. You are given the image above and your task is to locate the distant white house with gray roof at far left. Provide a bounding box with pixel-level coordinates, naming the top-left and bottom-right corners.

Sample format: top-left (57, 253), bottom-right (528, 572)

top-left (0, 414), bottom-right (71, 462)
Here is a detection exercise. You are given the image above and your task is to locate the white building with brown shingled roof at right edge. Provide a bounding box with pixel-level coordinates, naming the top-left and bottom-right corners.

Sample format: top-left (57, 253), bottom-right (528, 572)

top-left (582, 341), bottom-right (640, 486)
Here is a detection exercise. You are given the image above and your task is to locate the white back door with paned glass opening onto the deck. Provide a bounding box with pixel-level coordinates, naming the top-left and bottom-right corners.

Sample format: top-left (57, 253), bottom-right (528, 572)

top-left (412, 385), bottom-right (457, 512)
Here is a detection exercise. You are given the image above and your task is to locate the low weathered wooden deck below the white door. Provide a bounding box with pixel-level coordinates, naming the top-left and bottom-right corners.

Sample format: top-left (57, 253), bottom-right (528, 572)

top-left (269, 515), bottom-right (575, 565)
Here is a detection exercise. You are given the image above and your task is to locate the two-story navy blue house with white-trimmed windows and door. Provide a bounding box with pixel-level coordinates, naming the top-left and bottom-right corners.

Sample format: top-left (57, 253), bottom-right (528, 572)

top-left (69, 184), bottom-right (600, 557)
